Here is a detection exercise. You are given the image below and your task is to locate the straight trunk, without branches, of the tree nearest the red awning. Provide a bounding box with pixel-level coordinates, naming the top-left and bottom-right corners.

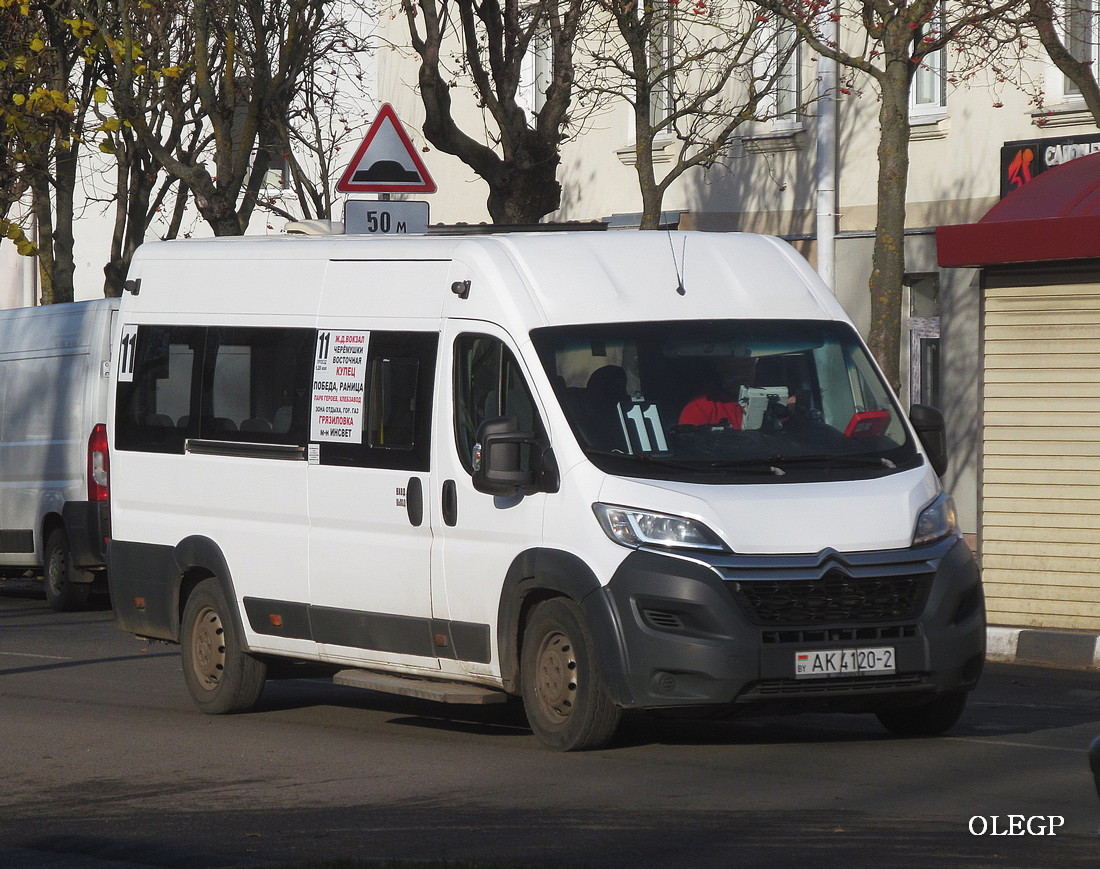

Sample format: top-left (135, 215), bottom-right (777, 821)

top-left (868, 61), bottom-right (910, 391)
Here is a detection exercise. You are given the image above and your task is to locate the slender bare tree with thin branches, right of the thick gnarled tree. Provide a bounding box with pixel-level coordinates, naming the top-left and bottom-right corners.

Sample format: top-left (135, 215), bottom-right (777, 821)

top-left (587, 0), bottom-right (798, 229)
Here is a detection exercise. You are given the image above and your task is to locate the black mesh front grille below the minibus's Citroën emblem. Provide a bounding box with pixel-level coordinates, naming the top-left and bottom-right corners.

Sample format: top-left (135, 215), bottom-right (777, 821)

top-left (730, 570), bottom-right (932, 627)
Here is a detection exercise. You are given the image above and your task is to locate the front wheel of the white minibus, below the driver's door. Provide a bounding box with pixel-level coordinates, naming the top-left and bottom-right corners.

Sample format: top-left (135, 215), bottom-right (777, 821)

top-left (519, 597), bottom-right (623, 751)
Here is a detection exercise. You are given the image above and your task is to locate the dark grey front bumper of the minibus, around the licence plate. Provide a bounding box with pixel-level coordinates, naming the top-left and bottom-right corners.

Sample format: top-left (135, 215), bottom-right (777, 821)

top-left (603, 538), bottom-right (986, 712)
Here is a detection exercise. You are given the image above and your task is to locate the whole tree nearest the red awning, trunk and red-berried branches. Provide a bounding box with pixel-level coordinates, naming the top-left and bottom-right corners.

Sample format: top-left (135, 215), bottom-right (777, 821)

top-left (751, 0), bottom-right (1021, 388)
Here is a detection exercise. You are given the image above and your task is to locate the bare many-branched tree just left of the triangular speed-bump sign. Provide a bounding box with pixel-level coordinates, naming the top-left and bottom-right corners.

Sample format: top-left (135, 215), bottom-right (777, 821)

top-left (97, 0), bottom-right (331, 235)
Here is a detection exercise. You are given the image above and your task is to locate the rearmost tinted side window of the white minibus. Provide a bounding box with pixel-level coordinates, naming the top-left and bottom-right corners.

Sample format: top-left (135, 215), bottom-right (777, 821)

top-left (114, 326), bottom-right (206, 453)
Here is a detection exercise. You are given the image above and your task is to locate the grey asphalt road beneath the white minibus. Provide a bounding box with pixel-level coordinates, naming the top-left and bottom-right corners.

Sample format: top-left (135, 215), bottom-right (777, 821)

top-left (0, 581), bottom-right (1100, 869)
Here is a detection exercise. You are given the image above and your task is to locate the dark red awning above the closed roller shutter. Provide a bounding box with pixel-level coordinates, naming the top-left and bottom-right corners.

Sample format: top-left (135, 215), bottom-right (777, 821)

top-left (936, 154), bottom-right (1100, 268)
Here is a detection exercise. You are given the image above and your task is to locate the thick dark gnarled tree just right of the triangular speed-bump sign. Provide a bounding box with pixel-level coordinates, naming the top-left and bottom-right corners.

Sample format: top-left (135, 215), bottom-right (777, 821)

top-left (402, 0), bottom-right (591, 223)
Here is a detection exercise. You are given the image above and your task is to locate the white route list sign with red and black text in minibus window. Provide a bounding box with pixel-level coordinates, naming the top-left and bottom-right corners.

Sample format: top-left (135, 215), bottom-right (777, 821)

top-left (309, 330), bottom-right (370, 443)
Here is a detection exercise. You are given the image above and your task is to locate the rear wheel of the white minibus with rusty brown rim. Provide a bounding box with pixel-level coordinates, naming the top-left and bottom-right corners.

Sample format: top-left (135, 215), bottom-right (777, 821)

top-left (179, 579), bottom-right (267, 715)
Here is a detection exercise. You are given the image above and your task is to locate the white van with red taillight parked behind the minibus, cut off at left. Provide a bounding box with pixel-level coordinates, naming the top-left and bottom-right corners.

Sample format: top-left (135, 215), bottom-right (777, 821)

top-left (0, 299), bottom-right (119, 611)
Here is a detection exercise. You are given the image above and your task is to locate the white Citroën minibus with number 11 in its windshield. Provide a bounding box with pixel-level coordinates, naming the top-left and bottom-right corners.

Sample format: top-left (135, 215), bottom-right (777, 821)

top-left (109, 232), bottom-right (985, 749)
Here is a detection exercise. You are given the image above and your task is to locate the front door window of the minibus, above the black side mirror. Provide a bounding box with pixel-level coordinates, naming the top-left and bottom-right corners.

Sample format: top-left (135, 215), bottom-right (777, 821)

top-left (454, 334), bottom-right (542, 474)
